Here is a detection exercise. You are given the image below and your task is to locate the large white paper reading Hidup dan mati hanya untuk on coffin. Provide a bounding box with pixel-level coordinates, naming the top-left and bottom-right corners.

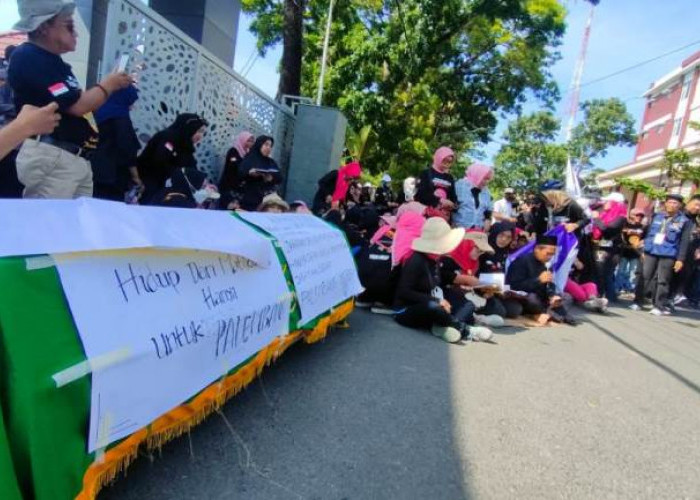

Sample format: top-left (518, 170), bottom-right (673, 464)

top-left (53, 248), bottom-right (291, 451)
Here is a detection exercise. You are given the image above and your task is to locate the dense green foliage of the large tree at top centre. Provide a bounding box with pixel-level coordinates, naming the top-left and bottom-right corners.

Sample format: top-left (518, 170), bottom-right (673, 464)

top-left (243, 0), bottom-right (565, 178)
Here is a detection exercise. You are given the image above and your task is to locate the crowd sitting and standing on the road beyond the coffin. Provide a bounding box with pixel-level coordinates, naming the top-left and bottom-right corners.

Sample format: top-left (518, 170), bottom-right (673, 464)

top-left (326, 147), bottom-right (700, 342)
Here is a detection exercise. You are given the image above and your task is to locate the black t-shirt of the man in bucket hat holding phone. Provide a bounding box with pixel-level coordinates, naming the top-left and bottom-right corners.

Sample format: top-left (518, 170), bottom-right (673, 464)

top-left (8, 42), bottom-right (97, 148)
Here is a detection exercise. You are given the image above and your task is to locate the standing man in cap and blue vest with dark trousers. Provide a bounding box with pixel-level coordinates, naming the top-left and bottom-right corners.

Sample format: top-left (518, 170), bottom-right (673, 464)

top-left (630, 194), bottom-right (693, 316)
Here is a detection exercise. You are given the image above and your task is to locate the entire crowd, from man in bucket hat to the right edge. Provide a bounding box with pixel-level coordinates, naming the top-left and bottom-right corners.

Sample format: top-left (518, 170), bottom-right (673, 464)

top-left (0, 0), bottom-right (700, 348)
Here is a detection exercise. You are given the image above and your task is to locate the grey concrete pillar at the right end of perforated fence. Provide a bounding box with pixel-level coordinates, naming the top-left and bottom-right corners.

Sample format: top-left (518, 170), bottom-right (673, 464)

top-left (285, 105), bottom-right (347, 203)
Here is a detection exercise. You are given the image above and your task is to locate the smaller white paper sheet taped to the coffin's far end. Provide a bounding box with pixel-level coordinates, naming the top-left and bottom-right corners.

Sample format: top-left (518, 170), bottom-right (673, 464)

top-left (240, 212), bottom-right (363, 325)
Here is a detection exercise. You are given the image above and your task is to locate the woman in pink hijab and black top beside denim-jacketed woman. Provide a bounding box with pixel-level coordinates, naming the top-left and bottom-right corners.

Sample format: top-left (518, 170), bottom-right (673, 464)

top-left (415, 146), bottom-right (457, 212)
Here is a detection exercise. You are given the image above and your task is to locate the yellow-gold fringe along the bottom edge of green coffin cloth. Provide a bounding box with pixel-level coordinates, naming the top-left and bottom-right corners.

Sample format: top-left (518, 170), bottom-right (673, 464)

top-left (76, 300), bottom-right (354, 500)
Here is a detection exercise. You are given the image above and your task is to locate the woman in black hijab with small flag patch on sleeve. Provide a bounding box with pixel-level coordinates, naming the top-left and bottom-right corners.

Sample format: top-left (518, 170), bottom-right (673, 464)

top-left (138, 113), bottom-right (208, 203)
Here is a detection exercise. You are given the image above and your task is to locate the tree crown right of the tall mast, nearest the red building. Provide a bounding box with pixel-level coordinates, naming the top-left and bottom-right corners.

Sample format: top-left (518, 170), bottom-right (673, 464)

top-left (568, 98), bottom-right (637, 172)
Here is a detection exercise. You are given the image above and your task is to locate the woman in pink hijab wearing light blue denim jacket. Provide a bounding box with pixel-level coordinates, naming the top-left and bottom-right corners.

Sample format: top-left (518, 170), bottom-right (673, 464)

top-left (454, 163), bottom-right (493, 230)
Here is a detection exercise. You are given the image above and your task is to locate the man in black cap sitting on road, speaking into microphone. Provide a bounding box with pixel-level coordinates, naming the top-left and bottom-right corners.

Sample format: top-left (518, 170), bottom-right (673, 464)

top-left (506, 235), bottom-right (576, 325)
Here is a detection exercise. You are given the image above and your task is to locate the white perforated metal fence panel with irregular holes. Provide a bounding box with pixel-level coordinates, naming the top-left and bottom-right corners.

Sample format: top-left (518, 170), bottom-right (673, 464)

top-left (102, 0), bottom-right (294, 185)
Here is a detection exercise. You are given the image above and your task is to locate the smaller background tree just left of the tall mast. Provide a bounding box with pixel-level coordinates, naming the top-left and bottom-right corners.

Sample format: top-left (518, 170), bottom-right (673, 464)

top-left (495, 111), bottom-right (566, 192)
